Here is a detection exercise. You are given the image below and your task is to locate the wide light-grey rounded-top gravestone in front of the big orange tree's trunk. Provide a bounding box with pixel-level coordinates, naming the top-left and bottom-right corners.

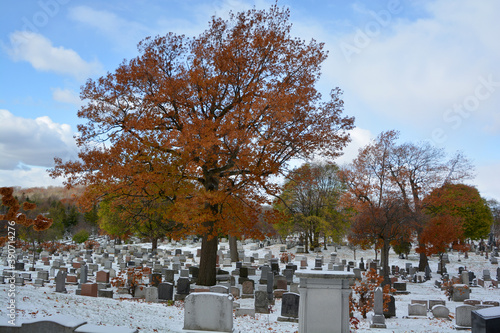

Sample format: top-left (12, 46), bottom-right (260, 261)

top-left (184, 292), bottom-right (233, 332)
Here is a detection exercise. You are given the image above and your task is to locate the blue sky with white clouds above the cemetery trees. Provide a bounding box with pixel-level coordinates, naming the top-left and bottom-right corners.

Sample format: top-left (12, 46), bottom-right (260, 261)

top-left (0, 0), bottom-right (500, 200)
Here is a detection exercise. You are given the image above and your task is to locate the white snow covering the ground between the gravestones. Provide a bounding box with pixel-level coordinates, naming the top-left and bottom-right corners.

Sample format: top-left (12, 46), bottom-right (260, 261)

top-left (0, 239), bottom-right (500, 333)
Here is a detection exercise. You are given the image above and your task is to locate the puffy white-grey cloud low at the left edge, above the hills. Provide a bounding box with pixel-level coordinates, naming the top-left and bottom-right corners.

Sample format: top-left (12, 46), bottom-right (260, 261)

top-left (0, 109), bottom-right (77, 170)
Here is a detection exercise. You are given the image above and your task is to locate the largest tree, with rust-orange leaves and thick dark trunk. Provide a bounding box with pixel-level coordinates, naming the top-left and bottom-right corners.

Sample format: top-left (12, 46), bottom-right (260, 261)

top-left (51, 5), bottom-right (353, 285)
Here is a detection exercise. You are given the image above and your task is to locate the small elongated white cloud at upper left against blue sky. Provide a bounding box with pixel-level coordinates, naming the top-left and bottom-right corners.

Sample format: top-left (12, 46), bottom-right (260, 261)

top-left (7, 31), bottom-right (102, 81)
